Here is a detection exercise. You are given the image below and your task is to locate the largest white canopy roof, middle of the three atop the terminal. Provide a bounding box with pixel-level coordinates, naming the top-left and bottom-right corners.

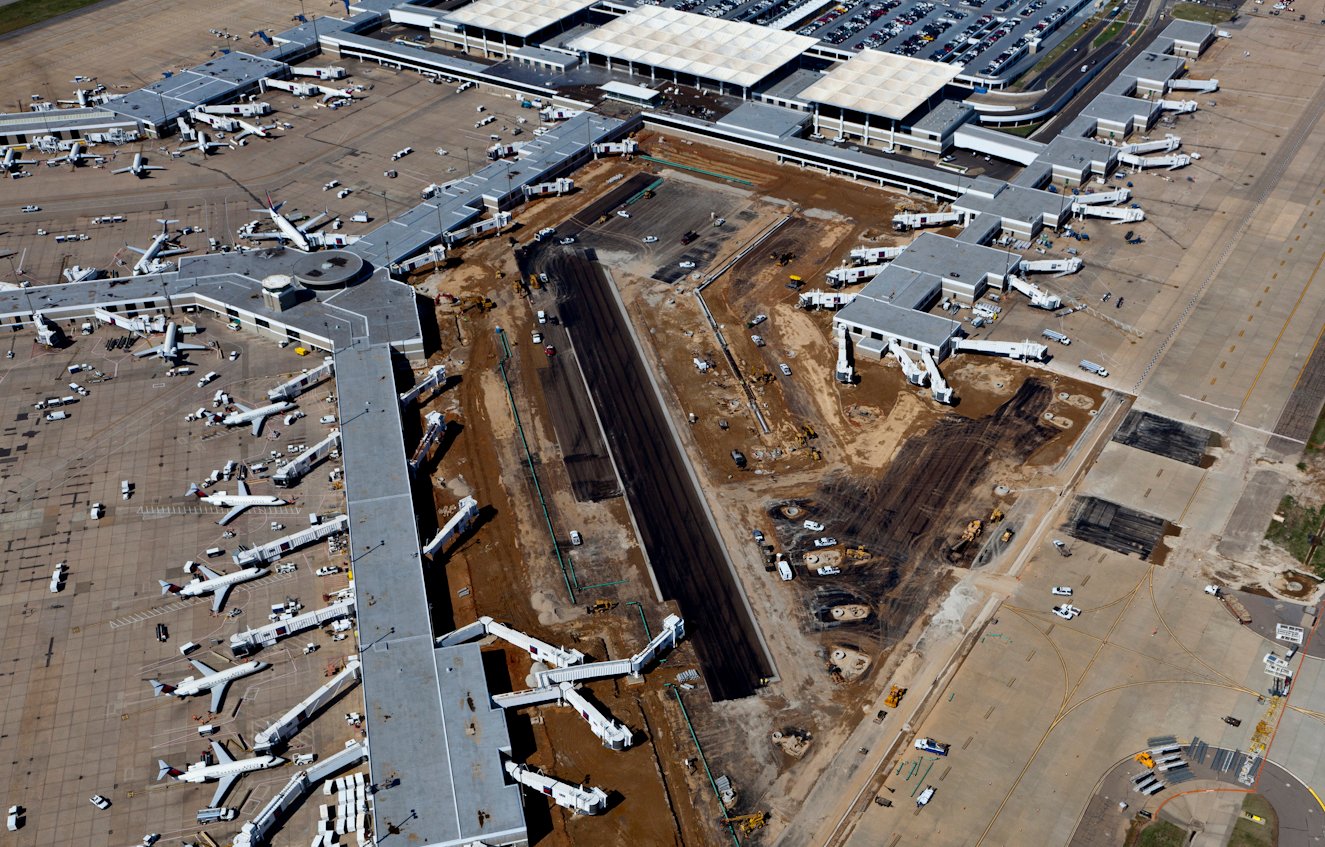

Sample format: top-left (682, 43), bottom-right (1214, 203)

top-left (567, 5), bottom-right (816, 87)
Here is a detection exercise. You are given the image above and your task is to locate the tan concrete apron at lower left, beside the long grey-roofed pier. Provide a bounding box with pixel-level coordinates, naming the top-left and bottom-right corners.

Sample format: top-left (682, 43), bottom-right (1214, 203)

top-left (0, 313), bottom-right (362, 846)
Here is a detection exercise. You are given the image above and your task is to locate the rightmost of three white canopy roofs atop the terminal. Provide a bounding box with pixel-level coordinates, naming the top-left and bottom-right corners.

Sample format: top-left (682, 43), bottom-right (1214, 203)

top-left (798, 50), bottom-right (962, 121)
